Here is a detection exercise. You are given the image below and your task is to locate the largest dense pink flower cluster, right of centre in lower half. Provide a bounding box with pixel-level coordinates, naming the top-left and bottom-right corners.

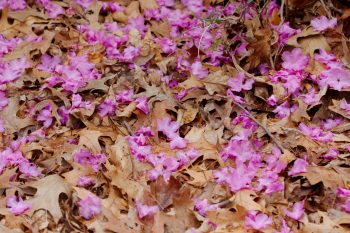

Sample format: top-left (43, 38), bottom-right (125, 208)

top-left (213, 130), bottom-right (286, 194)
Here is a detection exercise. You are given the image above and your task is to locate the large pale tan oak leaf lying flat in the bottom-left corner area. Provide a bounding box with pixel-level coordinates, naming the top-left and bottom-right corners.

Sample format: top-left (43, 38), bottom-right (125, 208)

top-left (26, 174), bottom-right (71, 221)
